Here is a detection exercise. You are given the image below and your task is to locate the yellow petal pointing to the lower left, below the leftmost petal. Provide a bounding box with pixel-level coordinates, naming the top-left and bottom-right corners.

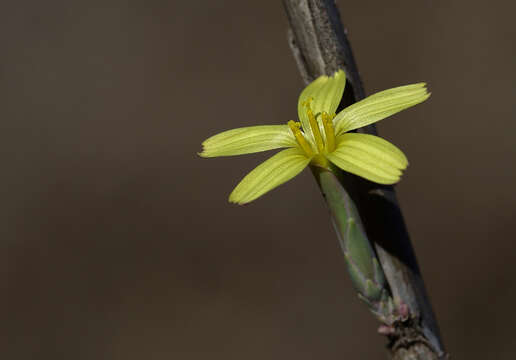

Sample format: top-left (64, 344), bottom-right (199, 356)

top-left (229, 148), bottom-right (310, 204)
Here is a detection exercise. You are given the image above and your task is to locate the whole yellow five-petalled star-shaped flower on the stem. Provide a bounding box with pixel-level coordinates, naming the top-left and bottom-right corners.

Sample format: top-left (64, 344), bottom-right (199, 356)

top-left (199, 70), bottom-right (430, 204)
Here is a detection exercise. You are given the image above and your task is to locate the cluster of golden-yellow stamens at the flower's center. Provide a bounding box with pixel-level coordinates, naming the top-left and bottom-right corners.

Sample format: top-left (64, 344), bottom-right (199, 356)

top-left (288, 98), bottom-right (335, 157)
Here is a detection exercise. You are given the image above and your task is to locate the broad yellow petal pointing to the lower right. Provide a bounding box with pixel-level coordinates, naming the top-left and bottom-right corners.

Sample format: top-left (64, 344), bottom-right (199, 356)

top-left (327, 133), bottom-right (408, 184)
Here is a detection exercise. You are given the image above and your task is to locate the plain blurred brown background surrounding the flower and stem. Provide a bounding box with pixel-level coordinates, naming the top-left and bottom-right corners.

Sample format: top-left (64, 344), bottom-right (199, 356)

top-left (4, 0), bottom-right (516, 360)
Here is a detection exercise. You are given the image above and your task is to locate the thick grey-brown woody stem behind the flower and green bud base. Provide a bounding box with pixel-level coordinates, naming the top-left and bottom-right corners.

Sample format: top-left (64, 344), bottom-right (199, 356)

top-left (283, 0), bottom-right (447, 359)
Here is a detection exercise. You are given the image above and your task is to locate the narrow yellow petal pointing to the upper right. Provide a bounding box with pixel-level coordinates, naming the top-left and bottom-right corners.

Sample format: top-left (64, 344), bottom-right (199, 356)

top-left (333, 83), bottom-right (430, 135)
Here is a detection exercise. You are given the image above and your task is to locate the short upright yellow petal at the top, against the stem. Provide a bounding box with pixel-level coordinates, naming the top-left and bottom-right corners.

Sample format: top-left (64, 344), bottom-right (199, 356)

top-left (297, 70), bottom-right (346, 138)
